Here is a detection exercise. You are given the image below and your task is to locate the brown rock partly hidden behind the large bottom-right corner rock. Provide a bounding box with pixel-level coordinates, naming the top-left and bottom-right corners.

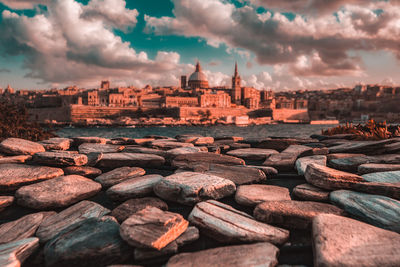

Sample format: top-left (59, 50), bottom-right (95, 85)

top-left (254, 200), bottom-right (345, 229)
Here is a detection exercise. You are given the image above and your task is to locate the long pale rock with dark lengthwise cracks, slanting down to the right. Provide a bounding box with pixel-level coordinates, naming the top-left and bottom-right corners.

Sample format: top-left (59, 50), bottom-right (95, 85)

top-left (189, 200), bottom-right (289, 247)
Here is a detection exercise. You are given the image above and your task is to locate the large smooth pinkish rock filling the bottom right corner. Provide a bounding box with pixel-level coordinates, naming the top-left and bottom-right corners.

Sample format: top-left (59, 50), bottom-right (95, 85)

top-left (312, 214), bottom-right (400, 267)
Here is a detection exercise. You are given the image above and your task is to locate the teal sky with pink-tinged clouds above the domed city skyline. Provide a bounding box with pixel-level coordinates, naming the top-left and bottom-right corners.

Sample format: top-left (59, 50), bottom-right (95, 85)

top-left (0, 0), bottom-right (400, 91)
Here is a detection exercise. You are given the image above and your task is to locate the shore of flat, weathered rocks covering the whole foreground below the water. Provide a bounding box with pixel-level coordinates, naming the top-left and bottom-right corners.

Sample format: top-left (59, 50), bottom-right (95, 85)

top-left (0, 134), bottom-right (400, 267)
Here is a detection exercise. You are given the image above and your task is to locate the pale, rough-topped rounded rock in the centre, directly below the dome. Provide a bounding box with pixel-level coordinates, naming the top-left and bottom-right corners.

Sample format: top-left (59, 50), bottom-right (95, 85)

top-left (153, 172), bottom-right (236, 205)
